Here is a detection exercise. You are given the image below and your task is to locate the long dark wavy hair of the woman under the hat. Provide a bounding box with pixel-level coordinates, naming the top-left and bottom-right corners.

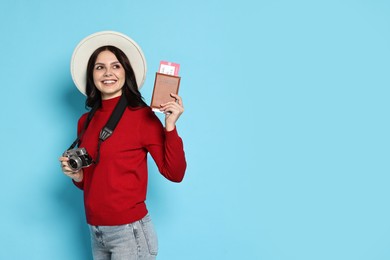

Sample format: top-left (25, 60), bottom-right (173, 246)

top-left (85, 46), bottom-right (147, 108)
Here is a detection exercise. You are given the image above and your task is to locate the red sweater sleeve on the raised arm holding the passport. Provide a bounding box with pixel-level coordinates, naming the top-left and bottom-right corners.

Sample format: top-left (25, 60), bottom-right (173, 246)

top-left (141, 110), bottom-right (187, 182)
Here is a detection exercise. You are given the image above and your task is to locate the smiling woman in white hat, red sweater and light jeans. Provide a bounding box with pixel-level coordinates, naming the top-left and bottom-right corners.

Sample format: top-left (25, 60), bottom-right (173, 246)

top-left (60, 32), bottom-right (186, 260)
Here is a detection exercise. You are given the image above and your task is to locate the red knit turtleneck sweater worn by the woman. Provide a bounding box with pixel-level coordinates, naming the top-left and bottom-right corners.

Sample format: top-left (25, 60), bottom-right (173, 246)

top-left (75, 97), bottom-right (186, 226)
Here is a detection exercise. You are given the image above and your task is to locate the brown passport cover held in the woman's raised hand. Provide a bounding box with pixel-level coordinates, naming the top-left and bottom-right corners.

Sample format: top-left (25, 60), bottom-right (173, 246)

top-left (150, 72), bottom-right (180, 109)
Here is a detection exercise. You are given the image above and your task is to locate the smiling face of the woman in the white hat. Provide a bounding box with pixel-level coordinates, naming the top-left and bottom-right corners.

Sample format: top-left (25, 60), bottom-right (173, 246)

top-left (93, 50), bottom-right (126, 100)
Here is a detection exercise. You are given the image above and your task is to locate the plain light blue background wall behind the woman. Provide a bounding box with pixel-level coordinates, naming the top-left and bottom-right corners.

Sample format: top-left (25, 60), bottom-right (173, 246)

top-left (0, 0), bottom-right (390, 260)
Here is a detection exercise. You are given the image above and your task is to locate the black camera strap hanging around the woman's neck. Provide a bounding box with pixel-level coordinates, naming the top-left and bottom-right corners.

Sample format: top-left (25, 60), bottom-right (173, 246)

top-left (68, 93), bottom-right (127, 164)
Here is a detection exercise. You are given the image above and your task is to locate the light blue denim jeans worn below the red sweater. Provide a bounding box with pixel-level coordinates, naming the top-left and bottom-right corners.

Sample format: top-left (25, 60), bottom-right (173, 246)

top-left (89, 215), bottom-right (158, 260)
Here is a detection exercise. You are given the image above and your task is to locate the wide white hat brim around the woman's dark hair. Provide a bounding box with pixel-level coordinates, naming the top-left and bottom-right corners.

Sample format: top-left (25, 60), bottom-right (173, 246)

top-left (70, 31), bottom-right (146, 95)
